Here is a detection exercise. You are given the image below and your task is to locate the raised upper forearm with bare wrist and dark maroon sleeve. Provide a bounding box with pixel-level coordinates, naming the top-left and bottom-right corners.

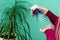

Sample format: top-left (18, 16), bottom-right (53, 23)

top-left (39, 7), bottom-right (58, 25)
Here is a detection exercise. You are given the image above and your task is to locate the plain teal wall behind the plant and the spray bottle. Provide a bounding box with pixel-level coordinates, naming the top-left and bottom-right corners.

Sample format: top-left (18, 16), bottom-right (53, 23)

top-left (0, 0), bottom-right (60, 40)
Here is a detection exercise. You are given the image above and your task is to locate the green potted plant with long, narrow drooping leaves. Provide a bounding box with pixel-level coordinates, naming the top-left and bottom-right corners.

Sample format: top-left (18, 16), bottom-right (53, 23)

top-left (0, 1), bottom-right (32, 40)
